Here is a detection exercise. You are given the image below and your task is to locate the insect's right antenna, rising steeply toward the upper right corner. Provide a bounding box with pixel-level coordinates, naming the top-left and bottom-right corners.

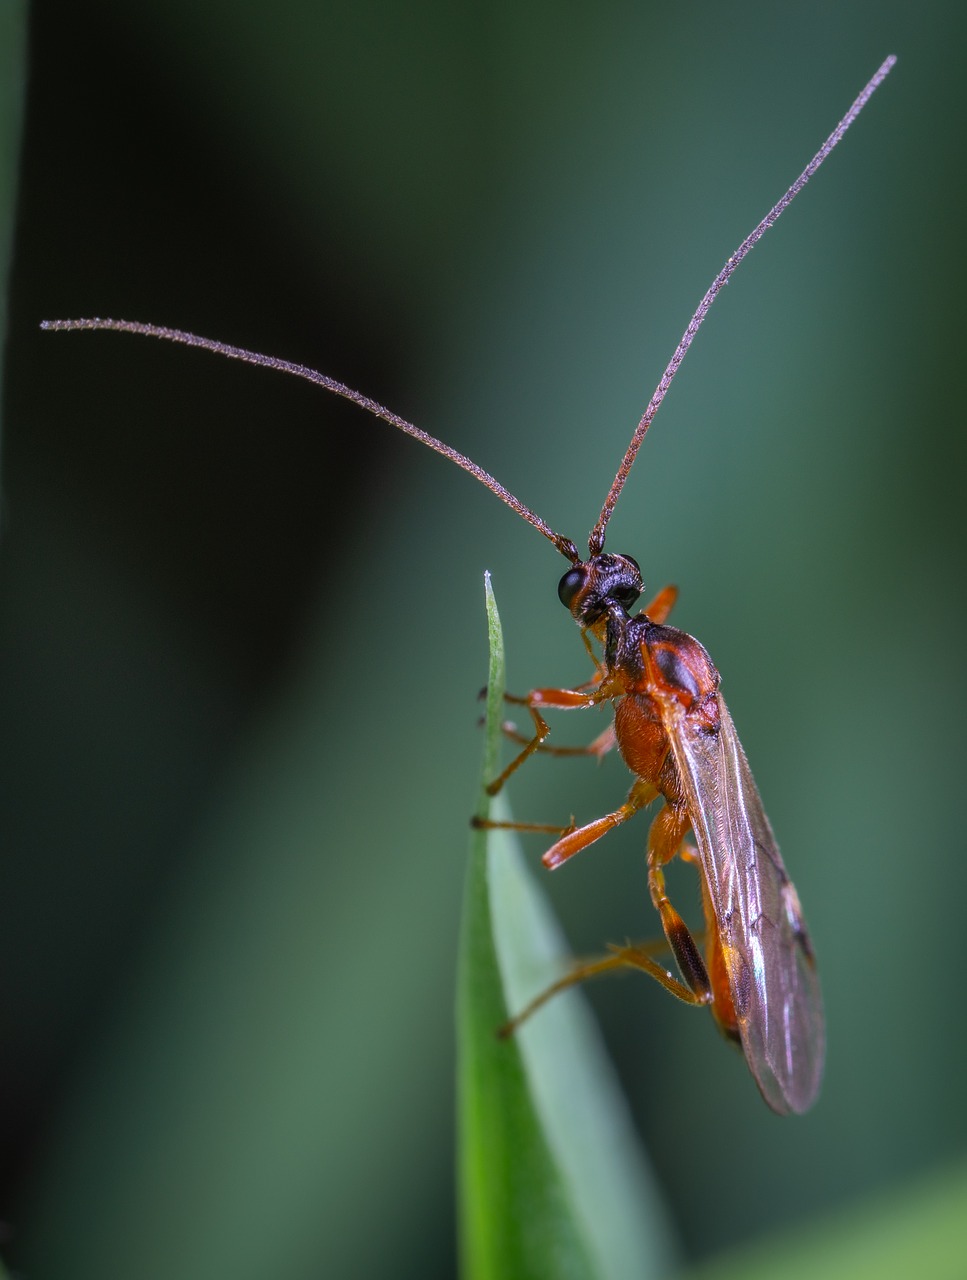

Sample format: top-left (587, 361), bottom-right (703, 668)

top-left (588, 54), bottom-right (897, 556)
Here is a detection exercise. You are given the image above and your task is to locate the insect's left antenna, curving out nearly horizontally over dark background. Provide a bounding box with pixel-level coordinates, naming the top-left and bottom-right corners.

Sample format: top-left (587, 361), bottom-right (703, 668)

top-left (41, 316), bottom-right (580, 564)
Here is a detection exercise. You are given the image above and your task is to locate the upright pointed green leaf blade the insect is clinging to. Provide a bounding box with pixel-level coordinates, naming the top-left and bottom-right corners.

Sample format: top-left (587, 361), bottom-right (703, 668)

top-left (457, 576), bottom-right (672, 1280)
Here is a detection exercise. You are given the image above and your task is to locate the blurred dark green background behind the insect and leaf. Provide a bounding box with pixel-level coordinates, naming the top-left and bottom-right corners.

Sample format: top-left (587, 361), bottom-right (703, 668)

top-left (0, 0), bottom-right (967, 1280)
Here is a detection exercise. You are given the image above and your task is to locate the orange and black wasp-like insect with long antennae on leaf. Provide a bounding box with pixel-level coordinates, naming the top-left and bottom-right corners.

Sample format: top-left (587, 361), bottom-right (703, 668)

top-left (42, 56), bottom-right (895, 1114)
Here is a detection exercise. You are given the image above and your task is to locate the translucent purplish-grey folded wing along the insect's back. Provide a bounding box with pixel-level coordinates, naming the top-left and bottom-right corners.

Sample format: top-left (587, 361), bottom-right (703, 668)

top-left (665, 695), bottom-right (826, 1114)
